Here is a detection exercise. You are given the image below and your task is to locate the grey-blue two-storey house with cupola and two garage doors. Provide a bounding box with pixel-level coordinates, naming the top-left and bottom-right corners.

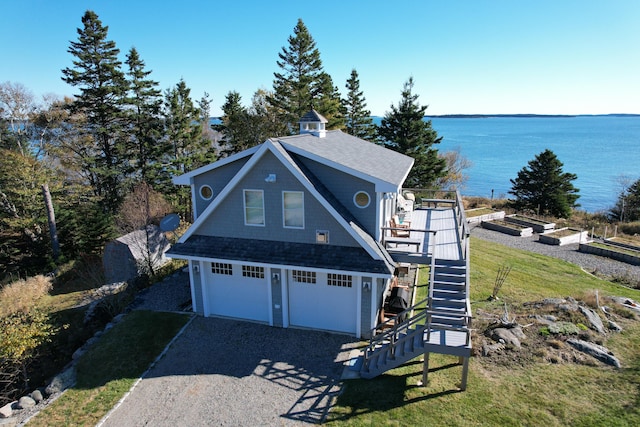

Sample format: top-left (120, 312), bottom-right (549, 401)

top-left (167, 110), bottom-right (413, 337)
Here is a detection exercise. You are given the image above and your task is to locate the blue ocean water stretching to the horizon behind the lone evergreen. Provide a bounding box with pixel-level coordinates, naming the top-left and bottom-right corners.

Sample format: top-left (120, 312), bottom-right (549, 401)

top-left (431, 116), bottom-right (640, 212)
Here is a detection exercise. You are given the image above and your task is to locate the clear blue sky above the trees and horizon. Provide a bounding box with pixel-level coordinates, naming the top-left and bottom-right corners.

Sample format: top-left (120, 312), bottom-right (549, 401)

top-left (0, 0), bottom-right (640, 115)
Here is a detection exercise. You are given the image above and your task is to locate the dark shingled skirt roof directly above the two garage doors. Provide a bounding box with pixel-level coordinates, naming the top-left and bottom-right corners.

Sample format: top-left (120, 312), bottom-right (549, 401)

top-left (167, 235), bottom-right (393, 275)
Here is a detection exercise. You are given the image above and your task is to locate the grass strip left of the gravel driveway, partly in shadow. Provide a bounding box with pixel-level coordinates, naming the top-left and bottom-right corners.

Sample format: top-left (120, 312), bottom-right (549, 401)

top-left (29, 311), bottom-right (189, 426)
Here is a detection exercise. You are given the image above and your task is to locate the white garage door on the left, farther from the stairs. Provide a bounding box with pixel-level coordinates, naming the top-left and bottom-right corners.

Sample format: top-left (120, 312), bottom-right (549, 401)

top-left (205, 263), bottom-right (269, 322)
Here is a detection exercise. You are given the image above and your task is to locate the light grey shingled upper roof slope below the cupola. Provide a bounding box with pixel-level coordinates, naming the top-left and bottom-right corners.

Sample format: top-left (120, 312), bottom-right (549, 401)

top-left (274, 130), bottom-right (413, 191)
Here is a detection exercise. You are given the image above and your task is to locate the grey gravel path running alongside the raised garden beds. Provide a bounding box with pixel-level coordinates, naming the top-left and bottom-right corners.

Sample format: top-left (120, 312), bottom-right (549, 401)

top-left (471, 226), bottom-right (640, 283)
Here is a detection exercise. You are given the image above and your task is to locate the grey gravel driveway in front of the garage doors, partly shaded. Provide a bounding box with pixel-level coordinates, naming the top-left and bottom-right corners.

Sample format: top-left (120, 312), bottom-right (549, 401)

top-left (103, 274), bottom-right (357, 427)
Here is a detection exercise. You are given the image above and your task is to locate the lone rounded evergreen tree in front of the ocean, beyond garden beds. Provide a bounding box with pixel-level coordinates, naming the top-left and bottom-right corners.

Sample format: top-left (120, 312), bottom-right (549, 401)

top-left (509, 149), bottom-right (580, 218)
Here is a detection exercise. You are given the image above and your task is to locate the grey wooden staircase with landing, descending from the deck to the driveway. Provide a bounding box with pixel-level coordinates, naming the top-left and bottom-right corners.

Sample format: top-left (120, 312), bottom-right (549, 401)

top-left (359, 259), bottom-right (471, 390)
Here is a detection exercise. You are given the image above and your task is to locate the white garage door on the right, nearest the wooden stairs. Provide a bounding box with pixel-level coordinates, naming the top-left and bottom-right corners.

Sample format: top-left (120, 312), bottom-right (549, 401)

top-left (288, 270), bottom-right (358, 334)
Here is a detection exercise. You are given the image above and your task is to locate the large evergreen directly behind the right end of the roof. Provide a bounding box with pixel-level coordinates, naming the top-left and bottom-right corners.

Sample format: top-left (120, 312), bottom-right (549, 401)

top-left (378, 77), bottom-right (447, 188)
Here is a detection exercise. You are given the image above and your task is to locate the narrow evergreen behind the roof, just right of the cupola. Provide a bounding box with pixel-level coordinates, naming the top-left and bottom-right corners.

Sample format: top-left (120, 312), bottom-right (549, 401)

top-left (342, 68), bottom-right (377, 141)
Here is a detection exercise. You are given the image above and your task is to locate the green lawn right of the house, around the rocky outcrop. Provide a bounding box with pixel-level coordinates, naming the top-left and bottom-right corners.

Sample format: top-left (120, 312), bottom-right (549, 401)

top-left (327, 238), bottom-right (640, 426)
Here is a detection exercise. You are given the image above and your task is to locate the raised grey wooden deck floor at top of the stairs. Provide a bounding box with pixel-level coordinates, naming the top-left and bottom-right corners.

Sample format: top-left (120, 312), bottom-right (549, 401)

top-left (388, 207), bottom-right (462, 260)
